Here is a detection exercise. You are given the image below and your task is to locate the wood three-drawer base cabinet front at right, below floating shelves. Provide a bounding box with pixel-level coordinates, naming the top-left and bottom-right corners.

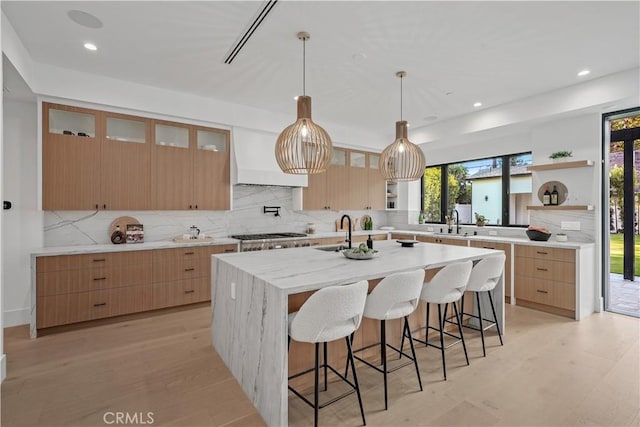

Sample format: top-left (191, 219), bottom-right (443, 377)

top-left (514, 245), bottom-right (576, 318)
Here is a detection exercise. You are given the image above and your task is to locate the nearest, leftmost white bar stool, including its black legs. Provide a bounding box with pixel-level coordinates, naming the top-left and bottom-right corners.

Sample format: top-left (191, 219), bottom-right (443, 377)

top-left (289, 280), bottom-right (369, 426)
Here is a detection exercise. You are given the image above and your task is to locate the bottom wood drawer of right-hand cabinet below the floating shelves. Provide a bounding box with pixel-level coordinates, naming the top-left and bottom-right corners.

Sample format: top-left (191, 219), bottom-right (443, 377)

top-left (515, 274), bottom-right (576, 310)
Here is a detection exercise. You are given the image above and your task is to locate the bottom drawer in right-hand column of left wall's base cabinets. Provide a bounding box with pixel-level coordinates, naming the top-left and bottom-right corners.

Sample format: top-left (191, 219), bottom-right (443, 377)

top-left (153, 277), bottom-right (211, 309)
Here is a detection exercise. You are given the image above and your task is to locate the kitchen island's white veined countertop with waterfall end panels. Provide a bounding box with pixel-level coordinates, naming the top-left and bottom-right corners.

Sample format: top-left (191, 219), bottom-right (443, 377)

top-left (211, 241), bottom-right (504, 426)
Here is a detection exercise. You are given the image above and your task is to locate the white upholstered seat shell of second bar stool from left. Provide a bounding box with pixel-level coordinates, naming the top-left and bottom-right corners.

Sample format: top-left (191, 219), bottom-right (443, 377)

top-left (364, 269), bottom-right (424, 320)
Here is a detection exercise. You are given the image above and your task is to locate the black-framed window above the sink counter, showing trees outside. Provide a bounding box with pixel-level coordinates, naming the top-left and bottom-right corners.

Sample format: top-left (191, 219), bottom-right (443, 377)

top-left (422, 153), bottom-right (532, 225)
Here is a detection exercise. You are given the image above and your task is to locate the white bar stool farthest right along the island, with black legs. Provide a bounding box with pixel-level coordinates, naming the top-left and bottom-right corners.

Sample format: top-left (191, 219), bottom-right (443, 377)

top-left (460, 254), bottom-right (505, 357)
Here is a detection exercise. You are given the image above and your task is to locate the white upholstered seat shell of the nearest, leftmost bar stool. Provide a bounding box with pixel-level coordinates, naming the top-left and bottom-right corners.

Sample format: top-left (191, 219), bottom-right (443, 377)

top-left (289, 280), bottom-right (369, 343)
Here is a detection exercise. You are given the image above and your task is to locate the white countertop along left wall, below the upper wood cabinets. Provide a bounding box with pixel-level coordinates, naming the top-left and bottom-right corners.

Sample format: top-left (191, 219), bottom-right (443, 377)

top-left (31, 237), bottom-right (238, 256)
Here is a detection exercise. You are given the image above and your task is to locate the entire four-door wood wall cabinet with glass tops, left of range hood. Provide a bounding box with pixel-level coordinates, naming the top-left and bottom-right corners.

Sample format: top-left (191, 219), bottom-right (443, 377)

top-left (43, 103), bottom-right (230, 210)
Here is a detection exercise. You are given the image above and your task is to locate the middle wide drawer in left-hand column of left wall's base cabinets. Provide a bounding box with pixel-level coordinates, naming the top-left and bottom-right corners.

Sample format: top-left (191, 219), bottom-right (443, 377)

top-left (36, 264), bottom-right (151, 296)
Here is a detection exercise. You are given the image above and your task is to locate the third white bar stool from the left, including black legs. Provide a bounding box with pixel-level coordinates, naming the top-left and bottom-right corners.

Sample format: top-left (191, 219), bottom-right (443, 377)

top-left (408, 261), bottom-right (473, 381)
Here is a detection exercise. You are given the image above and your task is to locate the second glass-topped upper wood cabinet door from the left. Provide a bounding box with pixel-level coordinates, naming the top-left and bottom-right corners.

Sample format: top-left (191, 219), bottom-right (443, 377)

top-left (101, 113), bottom-right (151, 210)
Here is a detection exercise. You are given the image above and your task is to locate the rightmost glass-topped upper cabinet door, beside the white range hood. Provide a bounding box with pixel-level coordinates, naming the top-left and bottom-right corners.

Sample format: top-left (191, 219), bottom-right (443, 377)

top-left (192, 127), bottom-right (231, 210)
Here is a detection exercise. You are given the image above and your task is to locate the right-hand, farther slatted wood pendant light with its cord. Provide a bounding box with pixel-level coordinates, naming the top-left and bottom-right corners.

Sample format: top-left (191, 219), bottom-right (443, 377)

top-left (379, 71), bottom-right (426, 181)
